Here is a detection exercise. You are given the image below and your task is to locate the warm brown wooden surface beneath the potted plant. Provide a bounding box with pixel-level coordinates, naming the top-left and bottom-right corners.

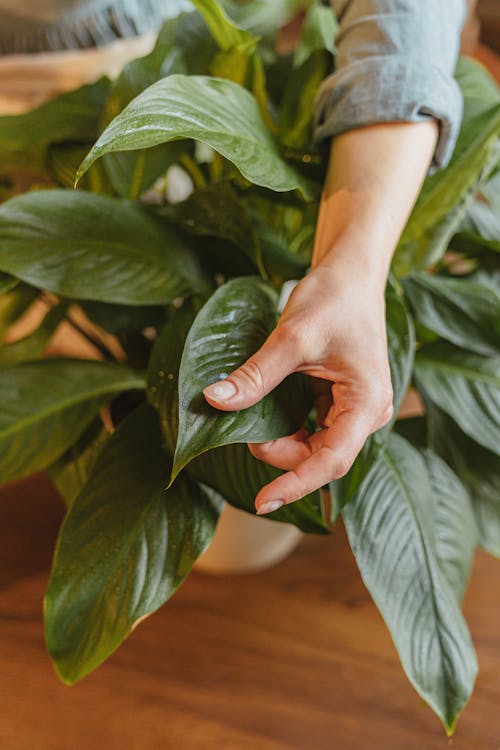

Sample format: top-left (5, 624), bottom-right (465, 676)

top-left (0, 477), bottom-right (500, 750)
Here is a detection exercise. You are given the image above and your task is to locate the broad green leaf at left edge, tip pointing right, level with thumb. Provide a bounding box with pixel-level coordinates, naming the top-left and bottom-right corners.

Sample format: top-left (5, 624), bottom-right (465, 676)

top-left (0, 359), bottom-right (145, 484)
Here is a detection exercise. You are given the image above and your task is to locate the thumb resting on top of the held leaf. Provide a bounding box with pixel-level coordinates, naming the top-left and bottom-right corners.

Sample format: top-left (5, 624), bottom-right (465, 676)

top-left (203, 328), bottom-right (298, 411)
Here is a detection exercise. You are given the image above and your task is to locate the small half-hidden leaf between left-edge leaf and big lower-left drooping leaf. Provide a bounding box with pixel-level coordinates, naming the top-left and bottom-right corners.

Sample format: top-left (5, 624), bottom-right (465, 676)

top-left (47, 417), bottom-right (110, 507)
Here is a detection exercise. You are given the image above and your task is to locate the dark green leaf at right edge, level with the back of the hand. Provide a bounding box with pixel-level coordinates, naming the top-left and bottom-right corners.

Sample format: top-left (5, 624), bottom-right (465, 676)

top-left (403, 273), bottom-right (500, 355)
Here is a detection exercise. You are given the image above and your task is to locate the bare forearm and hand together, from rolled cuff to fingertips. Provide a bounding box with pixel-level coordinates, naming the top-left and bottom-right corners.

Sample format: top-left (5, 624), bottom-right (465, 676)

top-left (204, 119), bottom-right (438, 514)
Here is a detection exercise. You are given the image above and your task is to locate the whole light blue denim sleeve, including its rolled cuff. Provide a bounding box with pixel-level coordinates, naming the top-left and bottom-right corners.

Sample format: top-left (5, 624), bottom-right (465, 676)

top-left (314, 0), bottom-right (466, 167)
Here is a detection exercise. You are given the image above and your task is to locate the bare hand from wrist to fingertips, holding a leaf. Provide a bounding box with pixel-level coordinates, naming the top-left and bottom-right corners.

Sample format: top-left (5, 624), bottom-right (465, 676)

top-left (204, 257), bottom-right (392, 514)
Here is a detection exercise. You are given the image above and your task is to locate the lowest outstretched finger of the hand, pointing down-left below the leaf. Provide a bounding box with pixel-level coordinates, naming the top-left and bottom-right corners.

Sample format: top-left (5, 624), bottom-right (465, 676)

top-left (252, 410), bottom-right (373, 515)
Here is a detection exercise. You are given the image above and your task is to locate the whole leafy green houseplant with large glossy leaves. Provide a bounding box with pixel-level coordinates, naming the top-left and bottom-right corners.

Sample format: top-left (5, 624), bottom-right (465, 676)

top-left (0, 0), bottom-right (500, 732)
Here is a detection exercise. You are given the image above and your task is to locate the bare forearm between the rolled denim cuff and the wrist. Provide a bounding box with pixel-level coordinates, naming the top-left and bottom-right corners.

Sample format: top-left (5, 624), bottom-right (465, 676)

top-left (312, 120), bottom-right (438, 286)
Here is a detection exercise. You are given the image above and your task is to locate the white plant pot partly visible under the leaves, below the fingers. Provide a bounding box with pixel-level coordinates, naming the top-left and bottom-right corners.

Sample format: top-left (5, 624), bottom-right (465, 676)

top-left (194, 503), bottom-right (303, 574)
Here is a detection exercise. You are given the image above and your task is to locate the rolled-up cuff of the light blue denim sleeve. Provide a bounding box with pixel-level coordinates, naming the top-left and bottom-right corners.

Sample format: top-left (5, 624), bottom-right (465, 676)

top-left (314, 55), bottom-right (463, 168)
